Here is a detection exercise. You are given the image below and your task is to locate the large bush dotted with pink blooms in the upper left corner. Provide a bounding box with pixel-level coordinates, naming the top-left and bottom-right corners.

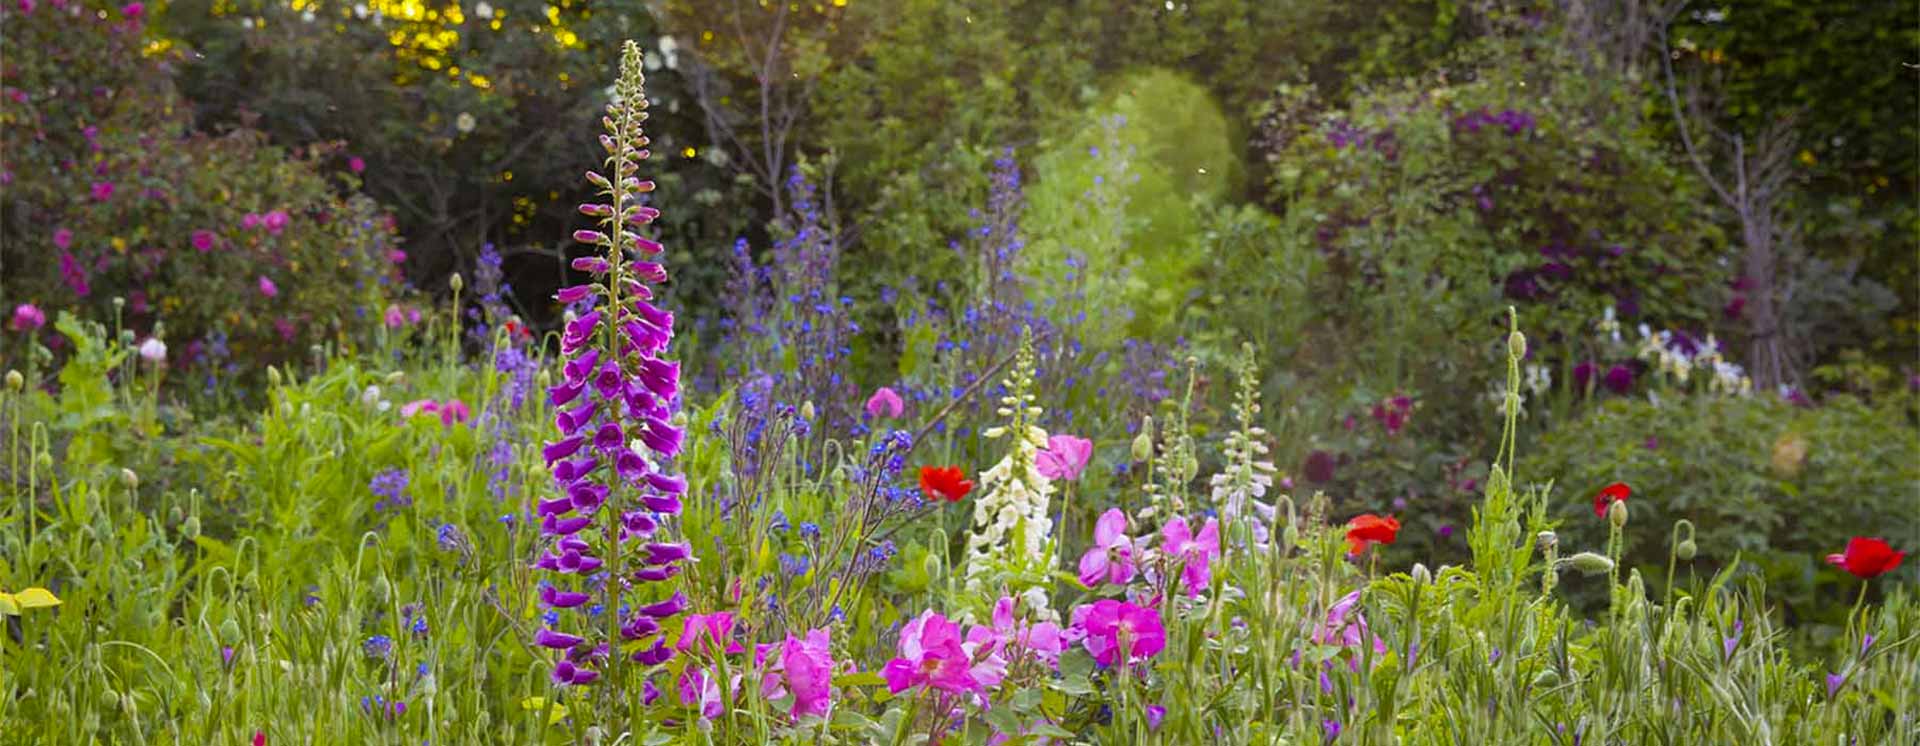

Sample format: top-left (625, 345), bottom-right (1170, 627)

top-left (0, 4), bottom-right (396, 362)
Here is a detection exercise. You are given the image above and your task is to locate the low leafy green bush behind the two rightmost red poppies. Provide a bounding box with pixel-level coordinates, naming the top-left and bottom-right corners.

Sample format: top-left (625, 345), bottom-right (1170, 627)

top-left (1521, 395), bottom-right (1920, 625)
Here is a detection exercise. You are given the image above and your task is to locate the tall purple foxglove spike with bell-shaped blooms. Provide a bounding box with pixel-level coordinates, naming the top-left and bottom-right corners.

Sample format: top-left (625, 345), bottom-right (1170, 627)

top-left (534, 42), bottom-right (689, 685)
